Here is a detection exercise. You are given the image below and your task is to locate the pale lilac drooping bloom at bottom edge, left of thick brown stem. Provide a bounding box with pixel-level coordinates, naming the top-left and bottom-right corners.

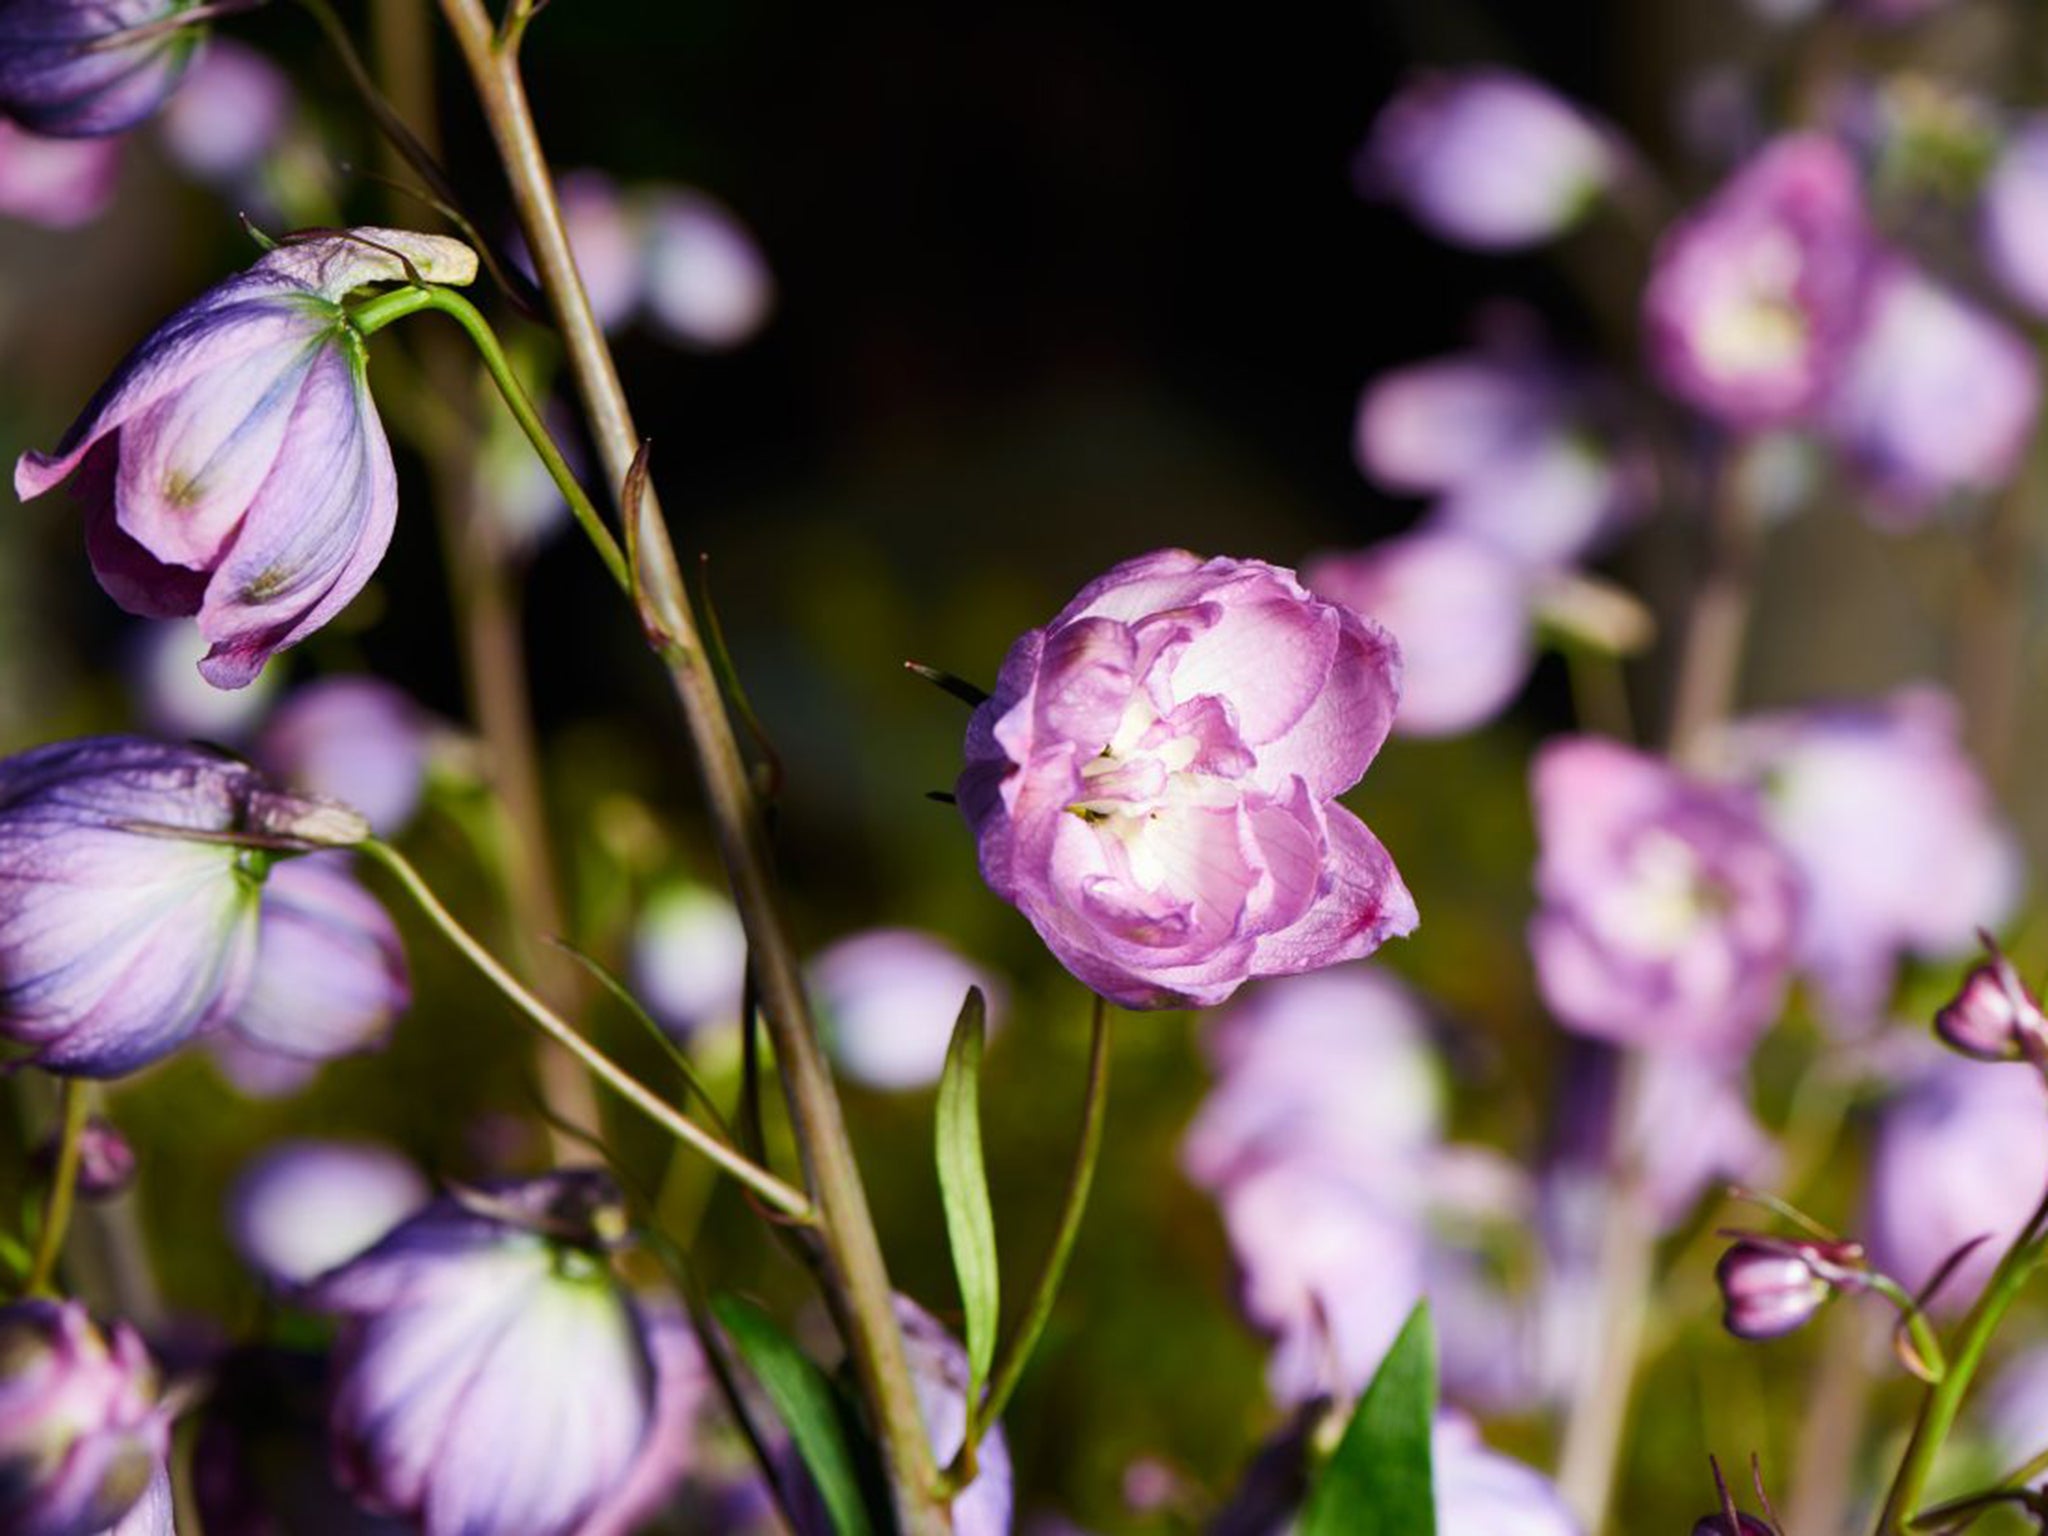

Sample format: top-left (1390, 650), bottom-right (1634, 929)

top-left (307, 1171), bottom-right (684, 1536)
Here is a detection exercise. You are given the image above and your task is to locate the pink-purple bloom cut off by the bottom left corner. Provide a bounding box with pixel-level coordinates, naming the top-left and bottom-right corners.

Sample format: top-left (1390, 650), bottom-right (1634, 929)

top-left (0, 1300), bottom-right (170, 1536)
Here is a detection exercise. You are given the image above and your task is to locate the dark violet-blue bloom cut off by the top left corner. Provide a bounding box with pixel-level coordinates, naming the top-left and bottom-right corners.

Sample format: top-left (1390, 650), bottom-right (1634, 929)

top-left (0, 0), bottom-right (201, 137)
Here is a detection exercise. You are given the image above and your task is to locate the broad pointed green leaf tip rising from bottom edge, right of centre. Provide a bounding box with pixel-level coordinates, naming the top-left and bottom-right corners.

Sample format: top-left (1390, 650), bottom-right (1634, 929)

top-left (1300, 1303), bottom-right (1436, 1536)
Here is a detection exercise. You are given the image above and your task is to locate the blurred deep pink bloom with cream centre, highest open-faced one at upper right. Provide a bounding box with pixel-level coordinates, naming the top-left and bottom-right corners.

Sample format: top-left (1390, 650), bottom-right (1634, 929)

top-left (1645, 133), bottom-right (1876, 428)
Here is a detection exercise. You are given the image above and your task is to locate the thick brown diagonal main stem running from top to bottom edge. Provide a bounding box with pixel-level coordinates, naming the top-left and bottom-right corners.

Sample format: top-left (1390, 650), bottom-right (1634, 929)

top-left (440, 0), bottom-right (948, 1536)
